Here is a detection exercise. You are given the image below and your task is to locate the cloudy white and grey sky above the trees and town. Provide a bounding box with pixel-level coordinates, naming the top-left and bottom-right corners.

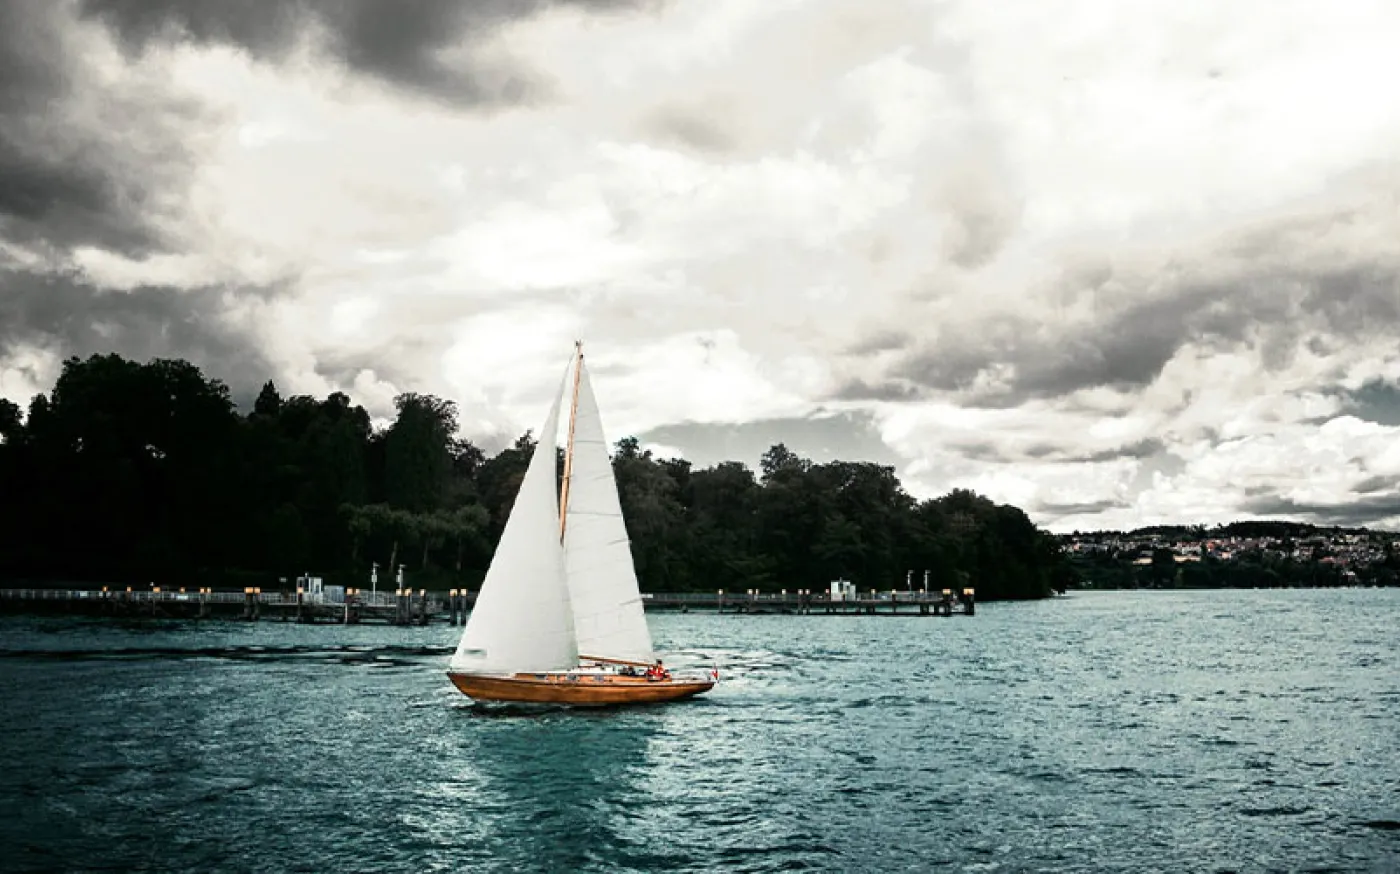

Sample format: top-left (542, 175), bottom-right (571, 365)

top-left (0, 0), bottom-right (1400, 531)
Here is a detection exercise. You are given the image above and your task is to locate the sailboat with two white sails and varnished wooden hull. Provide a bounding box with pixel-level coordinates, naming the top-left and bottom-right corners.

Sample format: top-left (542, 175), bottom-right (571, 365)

top-left (448, 337), bottom-right (718, 705)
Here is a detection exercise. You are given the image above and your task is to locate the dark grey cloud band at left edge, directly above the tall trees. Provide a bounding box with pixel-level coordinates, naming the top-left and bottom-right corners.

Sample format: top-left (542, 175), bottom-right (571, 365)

top-left (0, 270), bottom-right (277, 394)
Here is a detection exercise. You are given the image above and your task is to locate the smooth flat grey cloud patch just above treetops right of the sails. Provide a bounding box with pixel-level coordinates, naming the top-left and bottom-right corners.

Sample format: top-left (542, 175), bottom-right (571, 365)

top-left (637, 412), bottom-right (900, 466)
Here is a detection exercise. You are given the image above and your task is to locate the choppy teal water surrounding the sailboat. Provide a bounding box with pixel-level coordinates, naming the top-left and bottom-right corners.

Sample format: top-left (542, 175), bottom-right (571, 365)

top-left (0, 590), bottom-right (1400, 873)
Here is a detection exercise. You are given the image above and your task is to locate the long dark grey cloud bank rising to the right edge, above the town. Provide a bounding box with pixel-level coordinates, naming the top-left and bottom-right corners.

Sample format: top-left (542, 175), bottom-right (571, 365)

top-left (837, 187), bottom-right (1400, 408)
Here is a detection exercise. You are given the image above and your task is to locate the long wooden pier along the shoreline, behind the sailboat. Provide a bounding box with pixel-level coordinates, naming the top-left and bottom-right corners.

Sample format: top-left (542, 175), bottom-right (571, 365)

top-left (0, 585), bottom-right (976, 625)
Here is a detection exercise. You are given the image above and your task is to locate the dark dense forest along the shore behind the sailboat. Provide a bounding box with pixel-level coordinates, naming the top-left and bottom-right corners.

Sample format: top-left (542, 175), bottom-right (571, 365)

top-left (0, 354), bottom-right (1074, 599)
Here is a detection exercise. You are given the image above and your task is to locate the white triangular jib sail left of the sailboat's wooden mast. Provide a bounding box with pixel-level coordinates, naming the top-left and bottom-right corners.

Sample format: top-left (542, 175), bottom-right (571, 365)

top-left (451, 372), bottom-right (578, 674)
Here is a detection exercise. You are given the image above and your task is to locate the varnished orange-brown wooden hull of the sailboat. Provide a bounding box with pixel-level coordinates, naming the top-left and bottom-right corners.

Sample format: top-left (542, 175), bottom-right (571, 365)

top-left (447, 671), bottom-right (714, 707)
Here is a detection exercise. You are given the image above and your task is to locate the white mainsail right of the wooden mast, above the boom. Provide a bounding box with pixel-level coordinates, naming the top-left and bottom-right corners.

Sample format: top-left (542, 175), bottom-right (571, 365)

top-left (564, 360), bottom-right (654, 661)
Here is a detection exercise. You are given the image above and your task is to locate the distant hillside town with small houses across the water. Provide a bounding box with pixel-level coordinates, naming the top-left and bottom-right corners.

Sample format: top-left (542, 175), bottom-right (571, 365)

top-left (1060, 521), bottom-right (1400, 588)
